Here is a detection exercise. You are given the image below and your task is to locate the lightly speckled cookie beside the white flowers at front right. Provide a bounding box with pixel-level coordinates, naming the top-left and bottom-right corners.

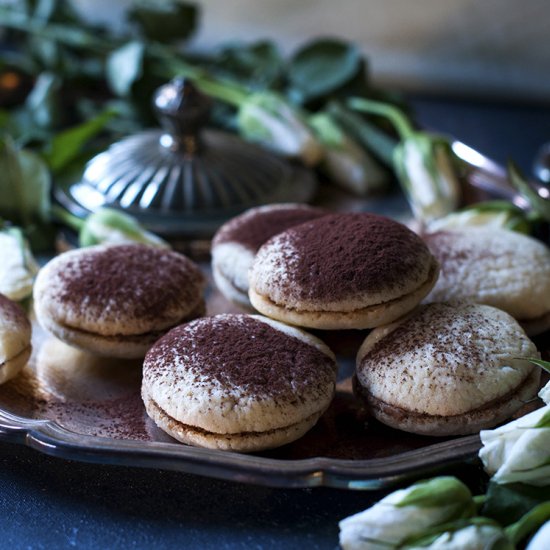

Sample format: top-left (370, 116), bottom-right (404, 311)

top-left (354, 303), bottom-right (540, 436)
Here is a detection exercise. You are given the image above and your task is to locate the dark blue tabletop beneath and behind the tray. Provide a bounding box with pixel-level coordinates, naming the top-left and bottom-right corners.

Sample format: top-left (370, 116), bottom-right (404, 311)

top-left (0, 92), bottom-right (550, 550)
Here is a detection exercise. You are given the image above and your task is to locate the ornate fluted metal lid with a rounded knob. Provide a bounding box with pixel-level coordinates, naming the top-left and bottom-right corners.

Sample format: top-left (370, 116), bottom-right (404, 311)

top-left (56, 79), bottom-right (316, 237)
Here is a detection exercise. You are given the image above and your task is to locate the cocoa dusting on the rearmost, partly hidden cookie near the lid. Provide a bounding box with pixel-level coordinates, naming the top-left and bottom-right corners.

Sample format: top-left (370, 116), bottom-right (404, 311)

top-left (212, 205), bottom-right (328, 252)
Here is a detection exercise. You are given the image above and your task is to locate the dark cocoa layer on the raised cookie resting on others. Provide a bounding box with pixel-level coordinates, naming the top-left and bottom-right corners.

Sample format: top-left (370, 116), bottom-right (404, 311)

top-left (270, 213), bottom-right (430, 300)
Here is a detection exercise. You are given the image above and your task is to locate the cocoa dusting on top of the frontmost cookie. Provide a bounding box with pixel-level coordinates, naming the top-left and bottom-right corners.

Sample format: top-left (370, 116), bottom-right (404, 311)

top-left (144, 314), bottom-right (336, 400)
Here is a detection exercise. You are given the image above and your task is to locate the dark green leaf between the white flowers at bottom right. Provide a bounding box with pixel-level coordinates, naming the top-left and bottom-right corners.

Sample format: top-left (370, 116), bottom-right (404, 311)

top-left (481, 481), bottom-right (548, 526)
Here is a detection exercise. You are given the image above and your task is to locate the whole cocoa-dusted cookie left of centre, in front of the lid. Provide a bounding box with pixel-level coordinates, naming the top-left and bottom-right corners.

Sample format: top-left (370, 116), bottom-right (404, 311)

top-left (34, 244), bottom-right (205, 358)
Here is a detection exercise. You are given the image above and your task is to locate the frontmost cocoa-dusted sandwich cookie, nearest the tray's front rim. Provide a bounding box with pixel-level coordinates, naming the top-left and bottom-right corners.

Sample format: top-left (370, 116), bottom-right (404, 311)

top-left (142, 314), bottom-right (337, 452)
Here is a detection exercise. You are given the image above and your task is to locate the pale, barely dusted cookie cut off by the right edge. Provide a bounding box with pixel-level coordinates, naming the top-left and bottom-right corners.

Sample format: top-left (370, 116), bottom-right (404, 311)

top-left (423, 227), bottom-right (550, 336)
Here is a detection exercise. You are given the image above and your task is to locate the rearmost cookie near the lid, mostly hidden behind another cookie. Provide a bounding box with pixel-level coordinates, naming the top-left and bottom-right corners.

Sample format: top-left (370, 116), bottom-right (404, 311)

top-left (212, 203), bottom-right (328, 308)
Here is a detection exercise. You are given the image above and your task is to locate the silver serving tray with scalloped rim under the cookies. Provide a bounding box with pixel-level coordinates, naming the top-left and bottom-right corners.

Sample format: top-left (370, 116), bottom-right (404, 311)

top-left (0, 142), bottom-right (547, 489)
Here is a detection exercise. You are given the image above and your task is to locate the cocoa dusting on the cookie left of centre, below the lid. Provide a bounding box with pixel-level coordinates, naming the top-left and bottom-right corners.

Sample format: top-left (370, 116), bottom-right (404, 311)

top-left (58, 244), bottom-right (204, 321)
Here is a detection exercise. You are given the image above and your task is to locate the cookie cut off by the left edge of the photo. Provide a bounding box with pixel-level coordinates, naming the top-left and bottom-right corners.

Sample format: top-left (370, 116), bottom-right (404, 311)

top-left (0, 294), bottom-right (32, 384)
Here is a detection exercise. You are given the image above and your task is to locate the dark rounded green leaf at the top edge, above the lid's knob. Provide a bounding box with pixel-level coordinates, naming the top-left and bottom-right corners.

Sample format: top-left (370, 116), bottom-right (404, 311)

top-left (128, 0), bottom-right (198, 43)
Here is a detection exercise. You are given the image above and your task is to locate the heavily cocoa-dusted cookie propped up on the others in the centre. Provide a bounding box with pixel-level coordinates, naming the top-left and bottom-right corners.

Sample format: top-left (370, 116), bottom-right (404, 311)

top-left (249, 213), bottom-right (439, 329)
